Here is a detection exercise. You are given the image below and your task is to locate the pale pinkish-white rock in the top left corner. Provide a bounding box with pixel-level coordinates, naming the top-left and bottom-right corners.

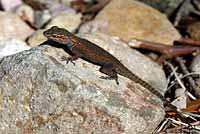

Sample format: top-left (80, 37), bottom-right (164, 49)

top-left (0, 0), bottom-right (22, 11)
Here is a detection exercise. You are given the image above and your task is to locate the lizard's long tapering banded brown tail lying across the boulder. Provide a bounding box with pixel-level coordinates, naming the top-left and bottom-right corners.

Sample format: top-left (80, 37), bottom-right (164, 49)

top-left (116, 66), bottom-right (165, 101)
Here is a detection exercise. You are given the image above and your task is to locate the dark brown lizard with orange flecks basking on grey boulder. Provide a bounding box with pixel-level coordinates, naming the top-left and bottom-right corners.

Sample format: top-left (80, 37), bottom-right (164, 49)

top-left (43, 26), bottom-right (165, 101)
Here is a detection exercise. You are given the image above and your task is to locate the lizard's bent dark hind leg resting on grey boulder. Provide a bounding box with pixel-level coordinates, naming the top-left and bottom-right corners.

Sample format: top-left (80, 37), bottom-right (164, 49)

top-left (99, 64), bottom-right (119, 85)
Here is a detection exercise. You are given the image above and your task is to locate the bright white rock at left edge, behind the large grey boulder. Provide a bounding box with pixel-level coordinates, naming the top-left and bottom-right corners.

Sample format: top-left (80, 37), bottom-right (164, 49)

top-left (0, 38), bottom-right (30, 58)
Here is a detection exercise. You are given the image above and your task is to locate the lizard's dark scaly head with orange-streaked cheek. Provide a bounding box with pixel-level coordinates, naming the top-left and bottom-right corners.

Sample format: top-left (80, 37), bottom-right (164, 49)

top-left (43, 26), bottom-right (72, 44)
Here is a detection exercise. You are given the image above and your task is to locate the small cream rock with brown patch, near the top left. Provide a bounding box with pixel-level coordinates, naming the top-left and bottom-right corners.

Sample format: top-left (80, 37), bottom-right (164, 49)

top-left (14, 4), bottom-right (34, 24)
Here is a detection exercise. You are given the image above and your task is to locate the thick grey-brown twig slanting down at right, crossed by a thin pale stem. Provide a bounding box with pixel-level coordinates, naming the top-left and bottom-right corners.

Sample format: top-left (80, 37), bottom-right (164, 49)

top-left (175, 57), bottom-right (200, 97)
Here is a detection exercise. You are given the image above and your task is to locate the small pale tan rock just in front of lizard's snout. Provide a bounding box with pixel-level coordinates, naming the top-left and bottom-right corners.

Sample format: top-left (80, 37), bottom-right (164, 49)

top-left (27, 29), bottom-right (47, 47)
